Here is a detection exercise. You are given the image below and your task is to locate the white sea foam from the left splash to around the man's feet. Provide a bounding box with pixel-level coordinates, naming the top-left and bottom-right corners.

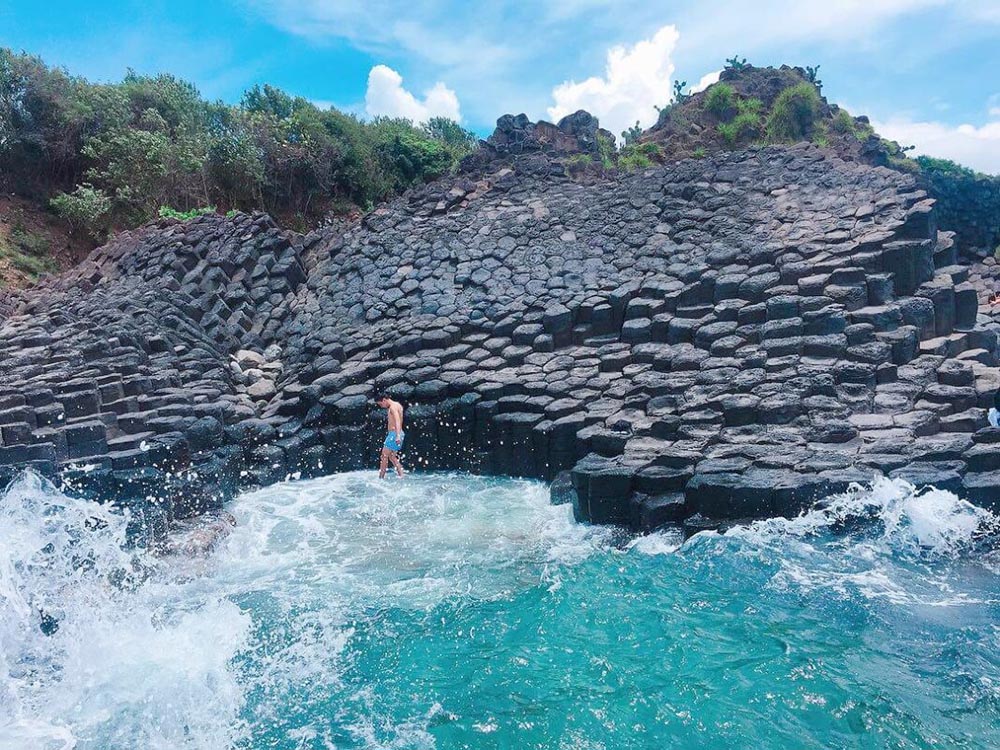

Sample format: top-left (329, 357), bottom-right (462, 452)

top-left (0, 473), bottom-right (606, 750)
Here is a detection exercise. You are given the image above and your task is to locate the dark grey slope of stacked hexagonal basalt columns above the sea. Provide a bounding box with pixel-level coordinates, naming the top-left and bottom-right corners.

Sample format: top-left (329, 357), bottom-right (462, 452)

top-left (0, 116), bottom-right (1000, 540)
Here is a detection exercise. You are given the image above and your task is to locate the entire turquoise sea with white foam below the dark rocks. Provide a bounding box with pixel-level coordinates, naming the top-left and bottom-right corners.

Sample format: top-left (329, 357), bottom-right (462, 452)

top-left (0, 473), bottom-right (1000, 750)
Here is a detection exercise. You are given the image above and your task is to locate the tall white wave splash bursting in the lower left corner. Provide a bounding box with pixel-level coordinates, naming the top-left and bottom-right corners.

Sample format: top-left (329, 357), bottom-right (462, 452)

top-left (0, 474), bottom-right (250, 750)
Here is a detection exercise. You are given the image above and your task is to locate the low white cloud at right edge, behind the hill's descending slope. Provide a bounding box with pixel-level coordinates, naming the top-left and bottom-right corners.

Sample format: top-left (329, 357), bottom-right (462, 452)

top-left (872, 113), bottom-right (1000, 174)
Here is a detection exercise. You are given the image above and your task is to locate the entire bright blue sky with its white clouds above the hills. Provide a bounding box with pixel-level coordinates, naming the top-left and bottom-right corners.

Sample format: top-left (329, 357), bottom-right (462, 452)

top-left (0, 0), bottom-right (1000, 173)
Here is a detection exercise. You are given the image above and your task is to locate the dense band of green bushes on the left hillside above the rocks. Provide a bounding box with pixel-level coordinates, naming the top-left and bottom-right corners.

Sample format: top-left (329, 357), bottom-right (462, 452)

top-left (0, 49), bottom-right (476, 235)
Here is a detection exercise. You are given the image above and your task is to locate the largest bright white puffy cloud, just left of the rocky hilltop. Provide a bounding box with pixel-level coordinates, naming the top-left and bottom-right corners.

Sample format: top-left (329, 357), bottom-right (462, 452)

top-left (548, 25), bottom-right (680, 141)
